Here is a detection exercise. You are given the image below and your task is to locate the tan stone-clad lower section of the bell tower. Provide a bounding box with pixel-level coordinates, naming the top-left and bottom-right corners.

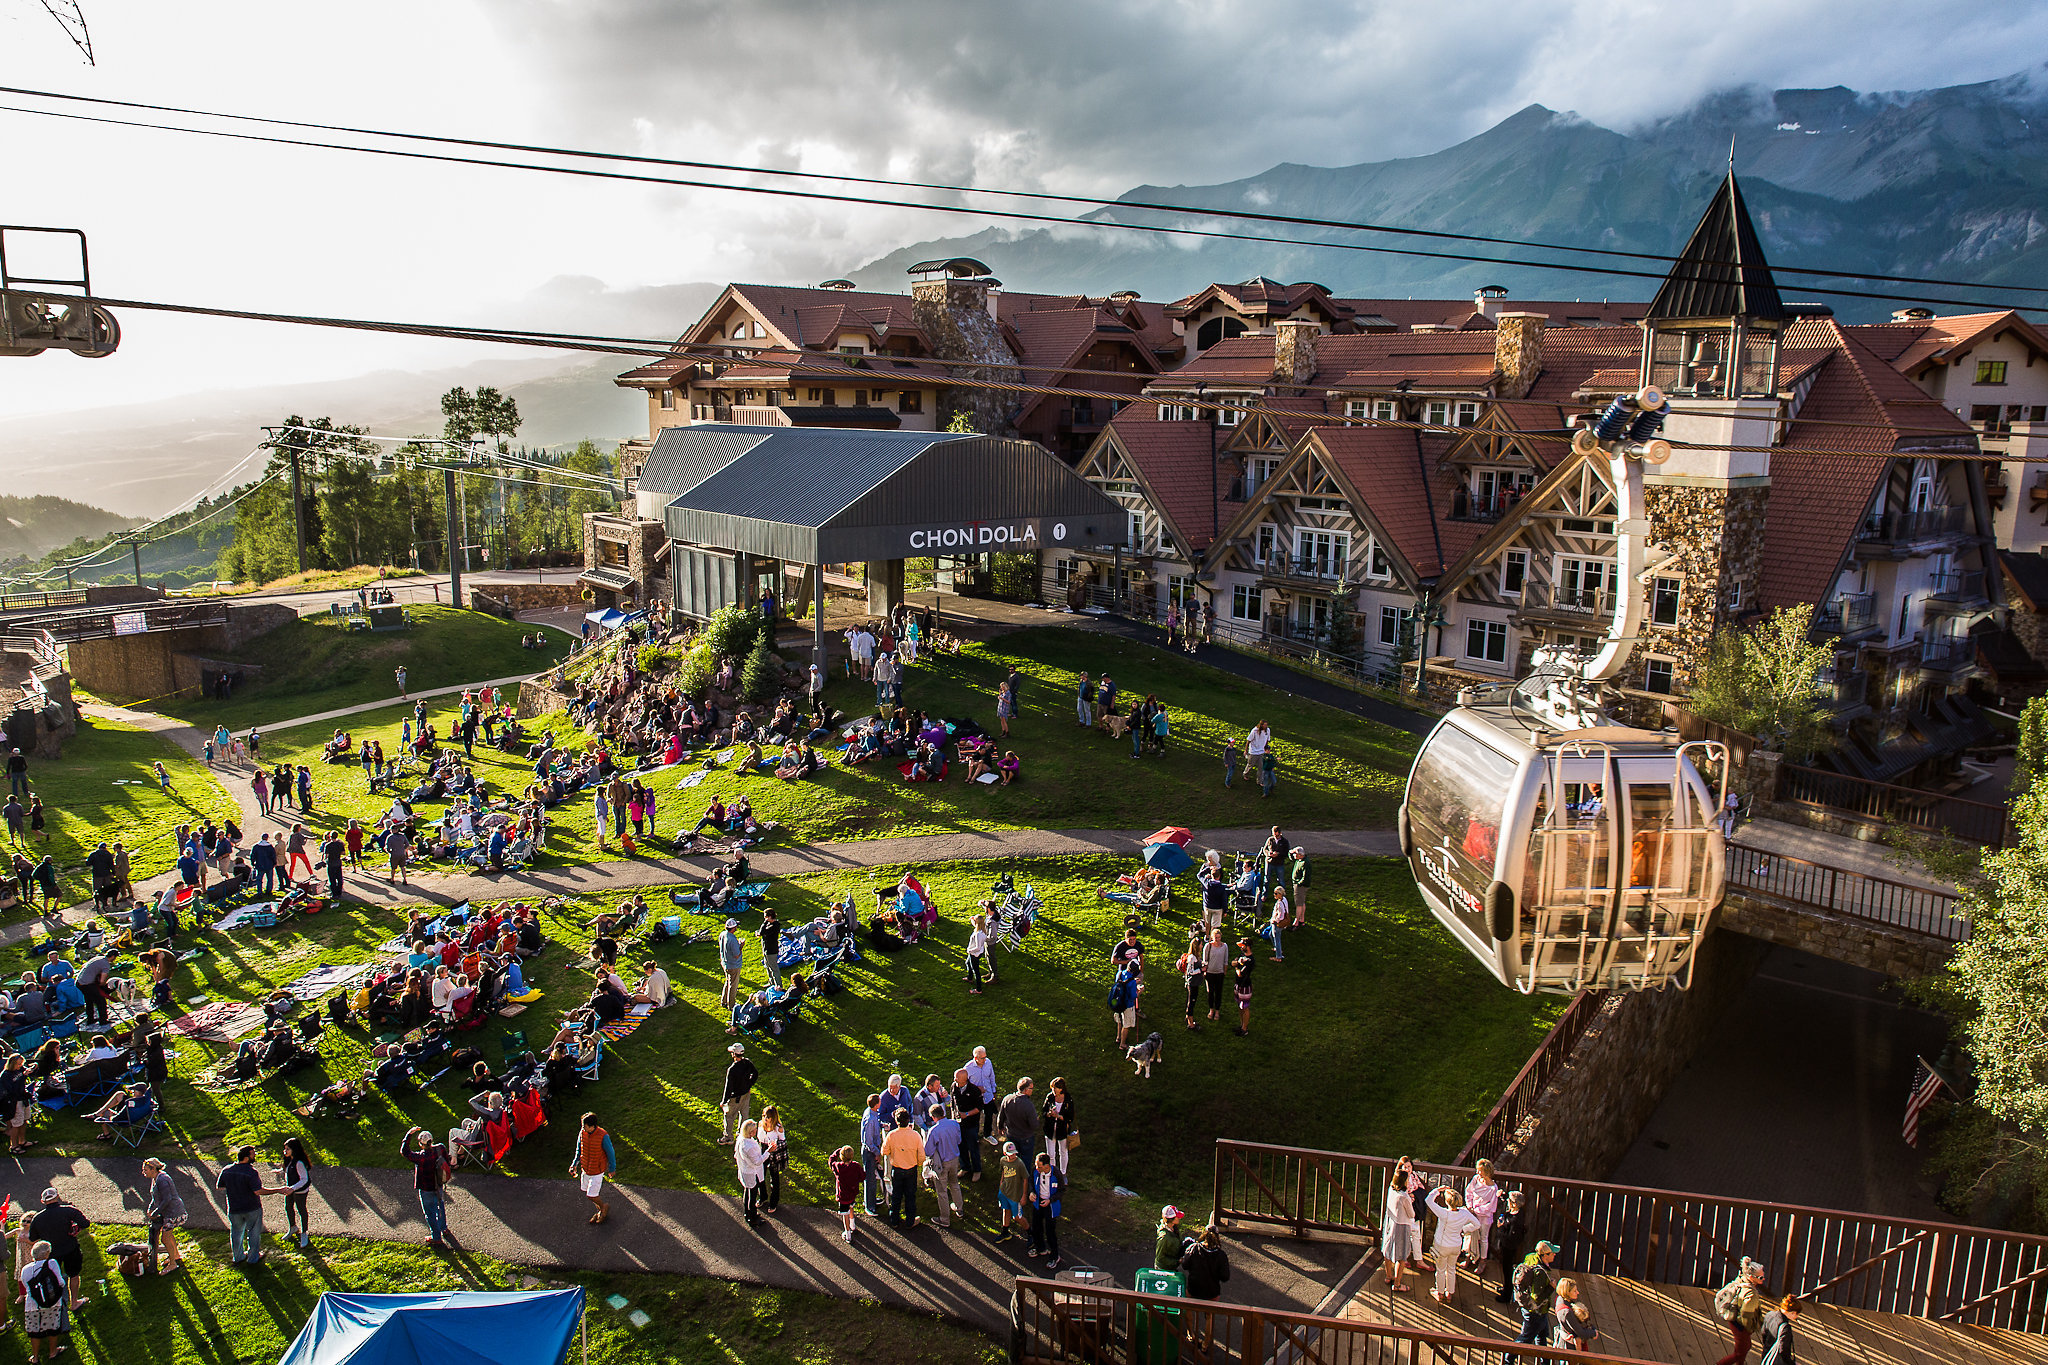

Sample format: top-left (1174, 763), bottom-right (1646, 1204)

top-left (1624, 483), bottom-right (1769, 696)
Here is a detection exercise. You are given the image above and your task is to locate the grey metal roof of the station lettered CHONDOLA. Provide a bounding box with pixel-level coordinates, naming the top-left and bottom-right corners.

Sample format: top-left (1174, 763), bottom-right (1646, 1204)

top-left (639, 424), bottom-right (1126, 565)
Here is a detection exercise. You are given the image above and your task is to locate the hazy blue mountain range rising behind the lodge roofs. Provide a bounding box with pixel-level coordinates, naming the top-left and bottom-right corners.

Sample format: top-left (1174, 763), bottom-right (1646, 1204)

top-left (852, 74), bottom-right (2048, 319)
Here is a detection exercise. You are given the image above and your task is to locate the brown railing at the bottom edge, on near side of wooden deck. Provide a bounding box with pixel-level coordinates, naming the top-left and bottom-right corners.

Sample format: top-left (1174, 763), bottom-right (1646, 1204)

top-left (1010, 1279), bottom-right (1640, 1365)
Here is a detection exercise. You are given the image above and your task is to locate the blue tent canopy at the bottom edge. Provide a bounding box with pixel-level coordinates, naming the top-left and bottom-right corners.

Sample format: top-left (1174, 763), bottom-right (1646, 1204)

top-left (279, 1289), bottom-right (584, 1365)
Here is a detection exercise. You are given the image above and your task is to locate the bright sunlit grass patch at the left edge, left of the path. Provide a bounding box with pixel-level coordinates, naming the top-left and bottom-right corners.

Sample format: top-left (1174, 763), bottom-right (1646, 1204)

top-left (0, 716), bottom-right (236, 919)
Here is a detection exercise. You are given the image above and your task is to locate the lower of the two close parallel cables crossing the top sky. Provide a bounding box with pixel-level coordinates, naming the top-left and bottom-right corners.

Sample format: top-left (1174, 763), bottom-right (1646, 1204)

top-left (0, 104), bottom-right (2044, 311)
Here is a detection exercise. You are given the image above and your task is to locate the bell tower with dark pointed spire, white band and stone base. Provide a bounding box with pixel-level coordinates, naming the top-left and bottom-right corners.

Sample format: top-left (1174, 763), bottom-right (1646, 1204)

top-left (1634, 166), bottom-right (1790, 692)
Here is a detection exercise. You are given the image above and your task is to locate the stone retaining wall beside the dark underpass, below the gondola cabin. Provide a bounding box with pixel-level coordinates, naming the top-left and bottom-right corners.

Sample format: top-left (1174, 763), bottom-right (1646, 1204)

top-left (1495, 929), bottom-right (1767, 1181)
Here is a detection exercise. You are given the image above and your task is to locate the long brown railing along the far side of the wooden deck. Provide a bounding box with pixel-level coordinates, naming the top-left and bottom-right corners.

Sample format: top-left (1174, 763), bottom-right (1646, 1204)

top-left (1214, 1138), bottom-right (2048, 1332)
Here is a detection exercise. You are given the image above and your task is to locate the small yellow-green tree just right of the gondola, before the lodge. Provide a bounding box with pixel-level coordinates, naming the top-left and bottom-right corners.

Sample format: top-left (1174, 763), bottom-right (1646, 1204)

top-left (1692, 602), bottom-right (1835, 759)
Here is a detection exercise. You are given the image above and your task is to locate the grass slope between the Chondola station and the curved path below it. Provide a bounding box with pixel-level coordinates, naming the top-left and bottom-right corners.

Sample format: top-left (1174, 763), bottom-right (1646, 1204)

top-left (247, 628), bottom-right (1415, 866)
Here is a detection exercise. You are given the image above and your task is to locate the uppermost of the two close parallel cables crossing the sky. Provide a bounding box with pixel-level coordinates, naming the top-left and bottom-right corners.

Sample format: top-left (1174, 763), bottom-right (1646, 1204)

top-left (0, 86), bottom-right (2048, 295)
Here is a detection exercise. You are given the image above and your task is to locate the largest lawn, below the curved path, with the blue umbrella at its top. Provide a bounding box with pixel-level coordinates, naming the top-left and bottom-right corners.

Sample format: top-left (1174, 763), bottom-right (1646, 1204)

top-left (37, 860), bottom-right (1556, 1232)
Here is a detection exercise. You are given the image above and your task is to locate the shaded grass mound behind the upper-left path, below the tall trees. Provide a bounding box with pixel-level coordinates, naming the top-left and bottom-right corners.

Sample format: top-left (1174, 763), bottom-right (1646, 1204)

top-left (158, 606), bottom-right (567, 731)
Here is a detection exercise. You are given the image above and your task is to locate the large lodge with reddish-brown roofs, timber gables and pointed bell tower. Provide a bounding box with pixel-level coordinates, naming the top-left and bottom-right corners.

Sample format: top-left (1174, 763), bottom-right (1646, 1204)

top-left (586, 174), bottom-right (2048, 780)
